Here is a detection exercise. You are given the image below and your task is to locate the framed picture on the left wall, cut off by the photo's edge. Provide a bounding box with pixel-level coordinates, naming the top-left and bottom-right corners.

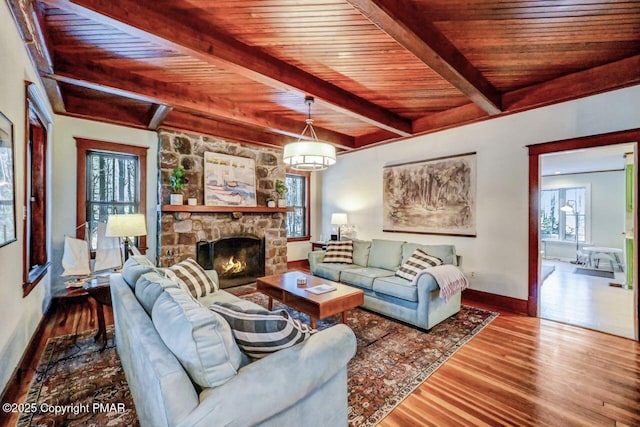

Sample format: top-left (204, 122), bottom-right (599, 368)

top-left (0, 113), bottom-right (16, 247)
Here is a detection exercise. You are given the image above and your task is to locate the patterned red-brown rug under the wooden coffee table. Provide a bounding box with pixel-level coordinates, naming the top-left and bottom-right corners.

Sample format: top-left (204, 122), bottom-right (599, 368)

top-left (241, 293), bottom-right (498, 426)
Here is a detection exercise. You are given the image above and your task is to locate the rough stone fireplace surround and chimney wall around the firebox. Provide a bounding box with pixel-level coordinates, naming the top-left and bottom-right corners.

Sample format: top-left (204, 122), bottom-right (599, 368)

top-left (157, 130), bottom-right (287, 280)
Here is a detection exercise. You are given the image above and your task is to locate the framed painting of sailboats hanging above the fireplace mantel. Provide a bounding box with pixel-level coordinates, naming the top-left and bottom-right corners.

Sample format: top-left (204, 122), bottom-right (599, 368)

top-left (204, 152), bottom-right (257, 207)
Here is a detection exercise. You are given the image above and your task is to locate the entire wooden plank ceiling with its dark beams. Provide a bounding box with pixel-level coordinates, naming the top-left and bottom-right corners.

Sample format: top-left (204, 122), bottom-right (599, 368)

top-left (8, 0), bottom-right (640, 150)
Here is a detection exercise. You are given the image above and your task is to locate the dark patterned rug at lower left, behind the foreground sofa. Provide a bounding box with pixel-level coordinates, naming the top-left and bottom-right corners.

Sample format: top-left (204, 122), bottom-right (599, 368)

top-left (16, 326), bottom-right (138, 427)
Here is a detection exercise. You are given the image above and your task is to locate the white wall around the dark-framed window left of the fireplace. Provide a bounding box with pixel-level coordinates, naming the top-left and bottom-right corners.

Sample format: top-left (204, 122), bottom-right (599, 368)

top-left (52, 115), bottom-right (158, 289)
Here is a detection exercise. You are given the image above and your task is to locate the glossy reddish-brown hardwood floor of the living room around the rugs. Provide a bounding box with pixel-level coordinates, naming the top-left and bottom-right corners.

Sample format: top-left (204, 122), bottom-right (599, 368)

top-left (0, 294), bottom-right (640, 427)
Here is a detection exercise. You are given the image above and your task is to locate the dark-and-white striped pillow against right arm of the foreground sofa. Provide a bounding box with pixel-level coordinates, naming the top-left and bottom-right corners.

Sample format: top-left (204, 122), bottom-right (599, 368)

top-left (209, 303), bottom-right (315, 359)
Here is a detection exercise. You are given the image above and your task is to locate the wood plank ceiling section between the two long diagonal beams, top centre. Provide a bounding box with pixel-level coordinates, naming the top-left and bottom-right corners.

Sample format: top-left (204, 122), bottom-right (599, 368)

top-left (163, 1), bottom-right (468, 118)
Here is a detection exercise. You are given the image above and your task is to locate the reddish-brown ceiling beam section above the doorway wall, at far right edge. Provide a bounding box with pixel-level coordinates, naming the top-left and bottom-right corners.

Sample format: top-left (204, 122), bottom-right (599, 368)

top-left (502, 55), bottom-right (640, 112)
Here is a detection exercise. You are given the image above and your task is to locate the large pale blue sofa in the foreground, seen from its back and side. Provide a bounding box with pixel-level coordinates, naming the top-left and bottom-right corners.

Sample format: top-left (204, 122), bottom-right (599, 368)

top-left (111, 257), bottom-right (356, 427)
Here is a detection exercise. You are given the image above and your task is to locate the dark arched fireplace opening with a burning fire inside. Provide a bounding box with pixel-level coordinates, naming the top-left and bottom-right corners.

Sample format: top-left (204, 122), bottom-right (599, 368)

top-left (196, 236), bottom-right (265, 288)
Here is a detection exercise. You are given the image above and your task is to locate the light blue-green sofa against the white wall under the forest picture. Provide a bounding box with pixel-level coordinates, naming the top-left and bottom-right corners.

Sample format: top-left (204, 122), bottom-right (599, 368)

top-left (308, 239), bottom-right (461, 329)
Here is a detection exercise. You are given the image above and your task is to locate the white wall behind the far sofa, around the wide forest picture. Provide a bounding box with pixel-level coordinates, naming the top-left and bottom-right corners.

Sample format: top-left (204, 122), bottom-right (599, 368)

top-left (321, 86), bottom-right (640, 299)
